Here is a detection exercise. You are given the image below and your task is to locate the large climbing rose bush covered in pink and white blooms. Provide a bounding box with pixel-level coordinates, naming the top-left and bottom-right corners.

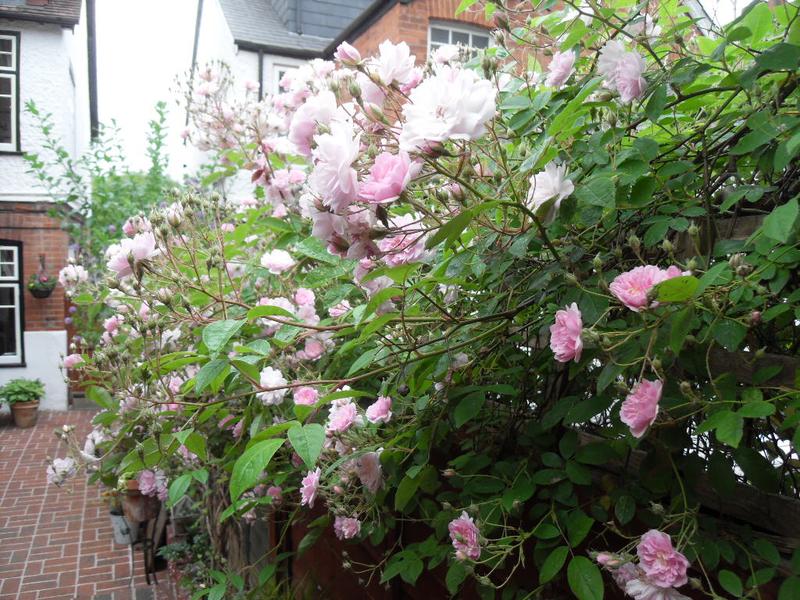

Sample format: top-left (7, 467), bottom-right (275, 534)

top-left (51, 0), bottom-right (800, 600)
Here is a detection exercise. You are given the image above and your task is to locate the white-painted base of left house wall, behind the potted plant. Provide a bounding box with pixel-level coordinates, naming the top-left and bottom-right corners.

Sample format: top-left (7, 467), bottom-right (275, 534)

top-left (0, 330), bottom-right (67, 410)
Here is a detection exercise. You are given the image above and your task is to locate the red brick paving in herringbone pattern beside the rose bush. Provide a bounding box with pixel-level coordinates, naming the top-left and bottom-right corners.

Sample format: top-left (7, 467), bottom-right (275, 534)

top-left (0, 411), bottom-right (172, 600)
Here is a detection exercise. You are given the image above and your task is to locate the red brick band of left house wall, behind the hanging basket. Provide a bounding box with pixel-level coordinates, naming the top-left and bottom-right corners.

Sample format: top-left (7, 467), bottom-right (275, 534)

top-left (0, 202), bottom-right (69, 331)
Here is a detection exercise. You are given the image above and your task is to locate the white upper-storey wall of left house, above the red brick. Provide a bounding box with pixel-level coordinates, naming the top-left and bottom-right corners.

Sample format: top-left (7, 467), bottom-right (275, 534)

top-left (0, 20), bottom-right (88, 202)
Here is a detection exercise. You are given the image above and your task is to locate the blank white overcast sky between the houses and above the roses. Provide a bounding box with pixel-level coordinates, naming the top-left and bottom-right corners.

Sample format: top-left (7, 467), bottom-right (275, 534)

top-left (96, 0), bottom-right (750, 180)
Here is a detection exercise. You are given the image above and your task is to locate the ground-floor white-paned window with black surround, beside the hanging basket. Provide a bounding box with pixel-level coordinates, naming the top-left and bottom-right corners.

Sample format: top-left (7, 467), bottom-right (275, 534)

top-left (0, 240), bottom-right (23, 365)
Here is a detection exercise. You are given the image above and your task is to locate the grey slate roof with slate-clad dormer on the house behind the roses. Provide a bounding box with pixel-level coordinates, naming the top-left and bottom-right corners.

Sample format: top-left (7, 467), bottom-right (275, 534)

top-left (220, 0), bottom-right (374, 56)
